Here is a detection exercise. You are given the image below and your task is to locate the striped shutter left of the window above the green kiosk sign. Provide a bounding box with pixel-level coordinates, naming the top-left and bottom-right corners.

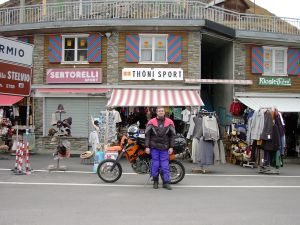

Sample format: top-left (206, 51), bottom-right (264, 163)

top-left (251, 46), bottom-right (264, 74)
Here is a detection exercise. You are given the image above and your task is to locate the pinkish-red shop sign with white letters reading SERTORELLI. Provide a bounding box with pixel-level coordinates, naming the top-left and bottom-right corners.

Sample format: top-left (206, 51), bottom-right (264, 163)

top-left (46, 68), bottom-right (102, 84)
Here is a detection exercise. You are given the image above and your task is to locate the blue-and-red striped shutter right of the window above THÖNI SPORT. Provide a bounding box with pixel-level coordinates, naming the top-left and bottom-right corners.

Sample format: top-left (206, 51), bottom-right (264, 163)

top-left (168, 34), bottom-right (182, 63)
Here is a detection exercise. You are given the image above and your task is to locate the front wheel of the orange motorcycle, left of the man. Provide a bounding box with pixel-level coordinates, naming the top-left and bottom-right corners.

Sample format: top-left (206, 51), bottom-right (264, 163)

top-left (97, 159), bottom-right (122, 183)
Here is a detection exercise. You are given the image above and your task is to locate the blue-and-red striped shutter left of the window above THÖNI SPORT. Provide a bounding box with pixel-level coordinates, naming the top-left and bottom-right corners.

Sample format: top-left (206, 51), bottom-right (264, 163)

top-left (125, 34), bottom-right (140, 62)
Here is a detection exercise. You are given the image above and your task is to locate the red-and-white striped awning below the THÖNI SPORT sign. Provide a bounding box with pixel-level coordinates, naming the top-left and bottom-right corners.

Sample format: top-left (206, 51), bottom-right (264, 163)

top-left (107, 89), bottom-right (204, 107)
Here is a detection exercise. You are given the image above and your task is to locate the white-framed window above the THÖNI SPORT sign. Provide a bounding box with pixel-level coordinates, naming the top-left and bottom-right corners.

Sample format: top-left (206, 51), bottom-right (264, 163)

top-left (140, 34), bottom-right (167, 63)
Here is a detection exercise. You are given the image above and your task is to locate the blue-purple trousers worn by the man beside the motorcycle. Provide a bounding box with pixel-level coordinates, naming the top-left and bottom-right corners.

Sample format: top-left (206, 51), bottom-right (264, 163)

top-left (151, 148), bottom-right (170, 183)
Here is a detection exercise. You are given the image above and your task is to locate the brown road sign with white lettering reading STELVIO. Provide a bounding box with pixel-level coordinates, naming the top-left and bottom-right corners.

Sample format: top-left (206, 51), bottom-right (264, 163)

top-left (0, 62), bottom-right (31, 96)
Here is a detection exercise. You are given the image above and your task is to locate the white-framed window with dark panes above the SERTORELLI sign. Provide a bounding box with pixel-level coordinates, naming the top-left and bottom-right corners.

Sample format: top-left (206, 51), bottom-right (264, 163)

top-left (62, 36), bottom-right (88, 63)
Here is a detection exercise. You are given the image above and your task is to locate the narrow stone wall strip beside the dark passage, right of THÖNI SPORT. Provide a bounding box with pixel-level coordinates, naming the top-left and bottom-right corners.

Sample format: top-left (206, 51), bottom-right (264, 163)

top-left (186, 32), bottom-right (201, 79)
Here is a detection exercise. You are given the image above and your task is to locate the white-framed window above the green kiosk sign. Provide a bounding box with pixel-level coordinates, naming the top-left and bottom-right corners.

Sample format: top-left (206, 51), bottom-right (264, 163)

top-left (264, 47), bottom-right (287, 76)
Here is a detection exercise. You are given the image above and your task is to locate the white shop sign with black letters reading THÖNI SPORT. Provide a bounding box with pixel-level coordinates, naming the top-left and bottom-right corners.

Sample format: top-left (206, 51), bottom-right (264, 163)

top-left (122, 68), bottom-right (183, 80)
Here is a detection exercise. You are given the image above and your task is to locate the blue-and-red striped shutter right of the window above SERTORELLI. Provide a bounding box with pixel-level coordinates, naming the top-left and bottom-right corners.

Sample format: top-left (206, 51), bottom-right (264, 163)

top-left (87, 34), bottom-right (102, 63)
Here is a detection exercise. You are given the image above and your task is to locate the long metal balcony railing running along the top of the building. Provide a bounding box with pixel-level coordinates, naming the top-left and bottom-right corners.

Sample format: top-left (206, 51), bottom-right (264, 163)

top-left (0, 0), bottom-right (300, 35)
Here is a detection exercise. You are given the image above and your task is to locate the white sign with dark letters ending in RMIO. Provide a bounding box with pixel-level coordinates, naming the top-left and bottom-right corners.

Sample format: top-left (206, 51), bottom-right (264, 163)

top-left (0, 37), bottom-right (33, 66)
